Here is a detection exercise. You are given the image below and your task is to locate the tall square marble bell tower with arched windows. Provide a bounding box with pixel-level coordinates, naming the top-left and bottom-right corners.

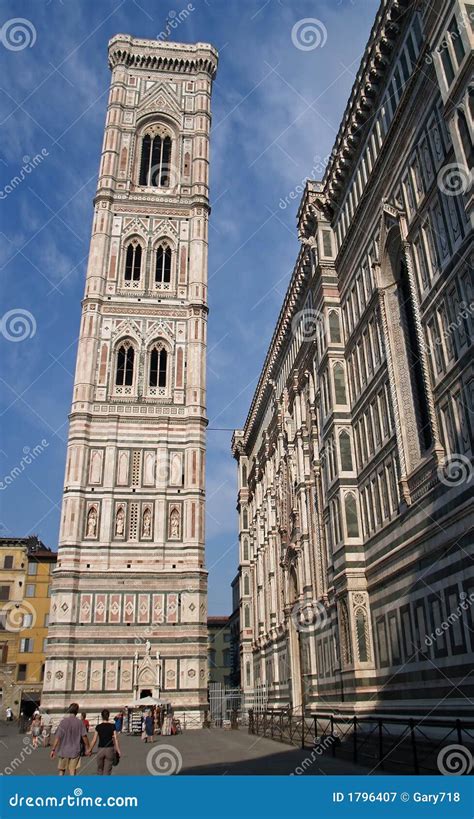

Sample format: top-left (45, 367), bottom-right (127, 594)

top-left (42, 35), bottom-right (217, 716)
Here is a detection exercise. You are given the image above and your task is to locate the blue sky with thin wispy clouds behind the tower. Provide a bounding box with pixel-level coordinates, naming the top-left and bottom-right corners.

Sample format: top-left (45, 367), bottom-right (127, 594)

top-left (0, 0), bottom-right (378, 614)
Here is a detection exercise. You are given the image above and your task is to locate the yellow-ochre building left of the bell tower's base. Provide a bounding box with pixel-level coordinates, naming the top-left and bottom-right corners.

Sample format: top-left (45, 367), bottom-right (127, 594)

top-left (0, 535), bottom-right (56, 718)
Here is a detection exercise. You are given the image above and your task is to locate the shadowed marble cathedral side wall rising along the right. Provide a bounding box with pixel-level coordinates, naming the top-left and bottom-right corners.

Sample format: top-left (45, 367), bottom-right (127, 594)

top-left (232, 0), bottom-right (474, 716)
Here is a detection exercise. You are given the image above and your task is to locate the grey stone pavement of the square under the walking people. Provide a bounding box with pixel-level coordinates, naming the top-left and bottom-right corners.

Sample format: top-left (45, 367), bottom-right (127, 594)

top-left (0, 723), bottom-right (378, 776)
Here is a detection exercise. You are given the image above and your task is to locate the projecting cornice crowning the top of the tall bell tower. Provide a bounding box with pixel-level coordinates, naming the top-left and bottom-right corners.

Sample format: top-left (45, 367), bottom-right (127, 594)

top-left (109, 34), bottom-right (218, 79)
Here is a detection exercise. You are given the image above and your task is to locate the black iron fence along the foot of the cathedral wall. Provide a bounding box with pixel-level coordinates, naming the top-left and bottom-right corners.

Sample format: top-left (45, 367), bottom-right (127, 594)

top-left (249, 710), bottom-right (474, 774)
